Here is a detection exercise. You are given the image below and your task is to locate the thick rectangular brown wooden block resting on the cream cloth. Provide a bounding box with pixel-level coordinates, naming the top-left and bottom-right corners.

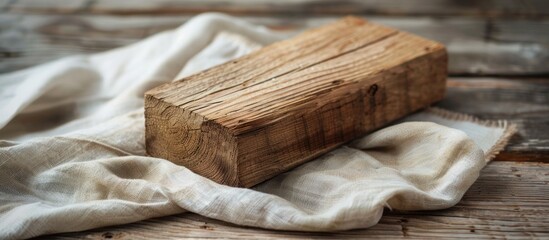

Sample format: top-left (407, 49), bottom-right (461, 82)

top-left (145, 17), bottom-right (447, 187)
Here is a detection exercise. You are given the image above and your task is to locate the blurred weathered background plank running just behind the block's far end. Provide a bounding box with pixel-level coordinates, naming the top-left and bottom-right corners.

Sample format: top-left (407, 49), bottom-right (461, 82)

top-left (0, 14), bottom-right (549, 76)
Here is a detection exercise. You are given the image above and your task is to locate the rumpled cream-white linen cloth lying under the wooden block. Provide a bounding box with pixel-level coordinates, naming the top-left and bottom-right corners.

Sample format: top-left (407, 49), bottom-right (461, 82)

top-left (0, 14), bottom-right (512, 239)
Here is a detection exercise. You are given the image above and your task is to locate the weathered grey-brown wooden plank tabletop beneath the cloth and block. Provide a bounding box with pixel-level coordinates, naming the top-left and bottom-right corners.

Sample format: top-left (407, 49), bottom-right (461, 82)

top-left (0, 0), bottom-right (549, 239)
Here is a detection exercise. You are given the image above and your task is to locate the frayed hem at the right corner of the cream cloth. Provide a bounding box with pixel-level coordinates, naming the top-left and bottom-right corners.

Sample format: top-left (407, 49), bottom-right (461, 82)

top-left (426, 107), bottom-right (518, 162)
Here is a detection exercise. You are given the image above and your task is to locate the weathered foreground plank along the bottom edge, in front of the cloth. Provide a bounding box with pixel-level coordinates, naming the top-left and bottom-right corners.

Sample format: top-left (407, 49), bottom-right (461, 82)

top-left (40, 162), bottom-right (549, 239)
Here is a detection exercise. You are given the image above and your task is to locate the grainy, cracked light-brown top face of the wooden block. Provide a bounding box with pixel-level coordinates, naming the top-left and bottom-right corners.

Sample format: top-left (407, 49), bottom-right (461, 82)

top-left (146, 17), bottom-right (444, 134)
